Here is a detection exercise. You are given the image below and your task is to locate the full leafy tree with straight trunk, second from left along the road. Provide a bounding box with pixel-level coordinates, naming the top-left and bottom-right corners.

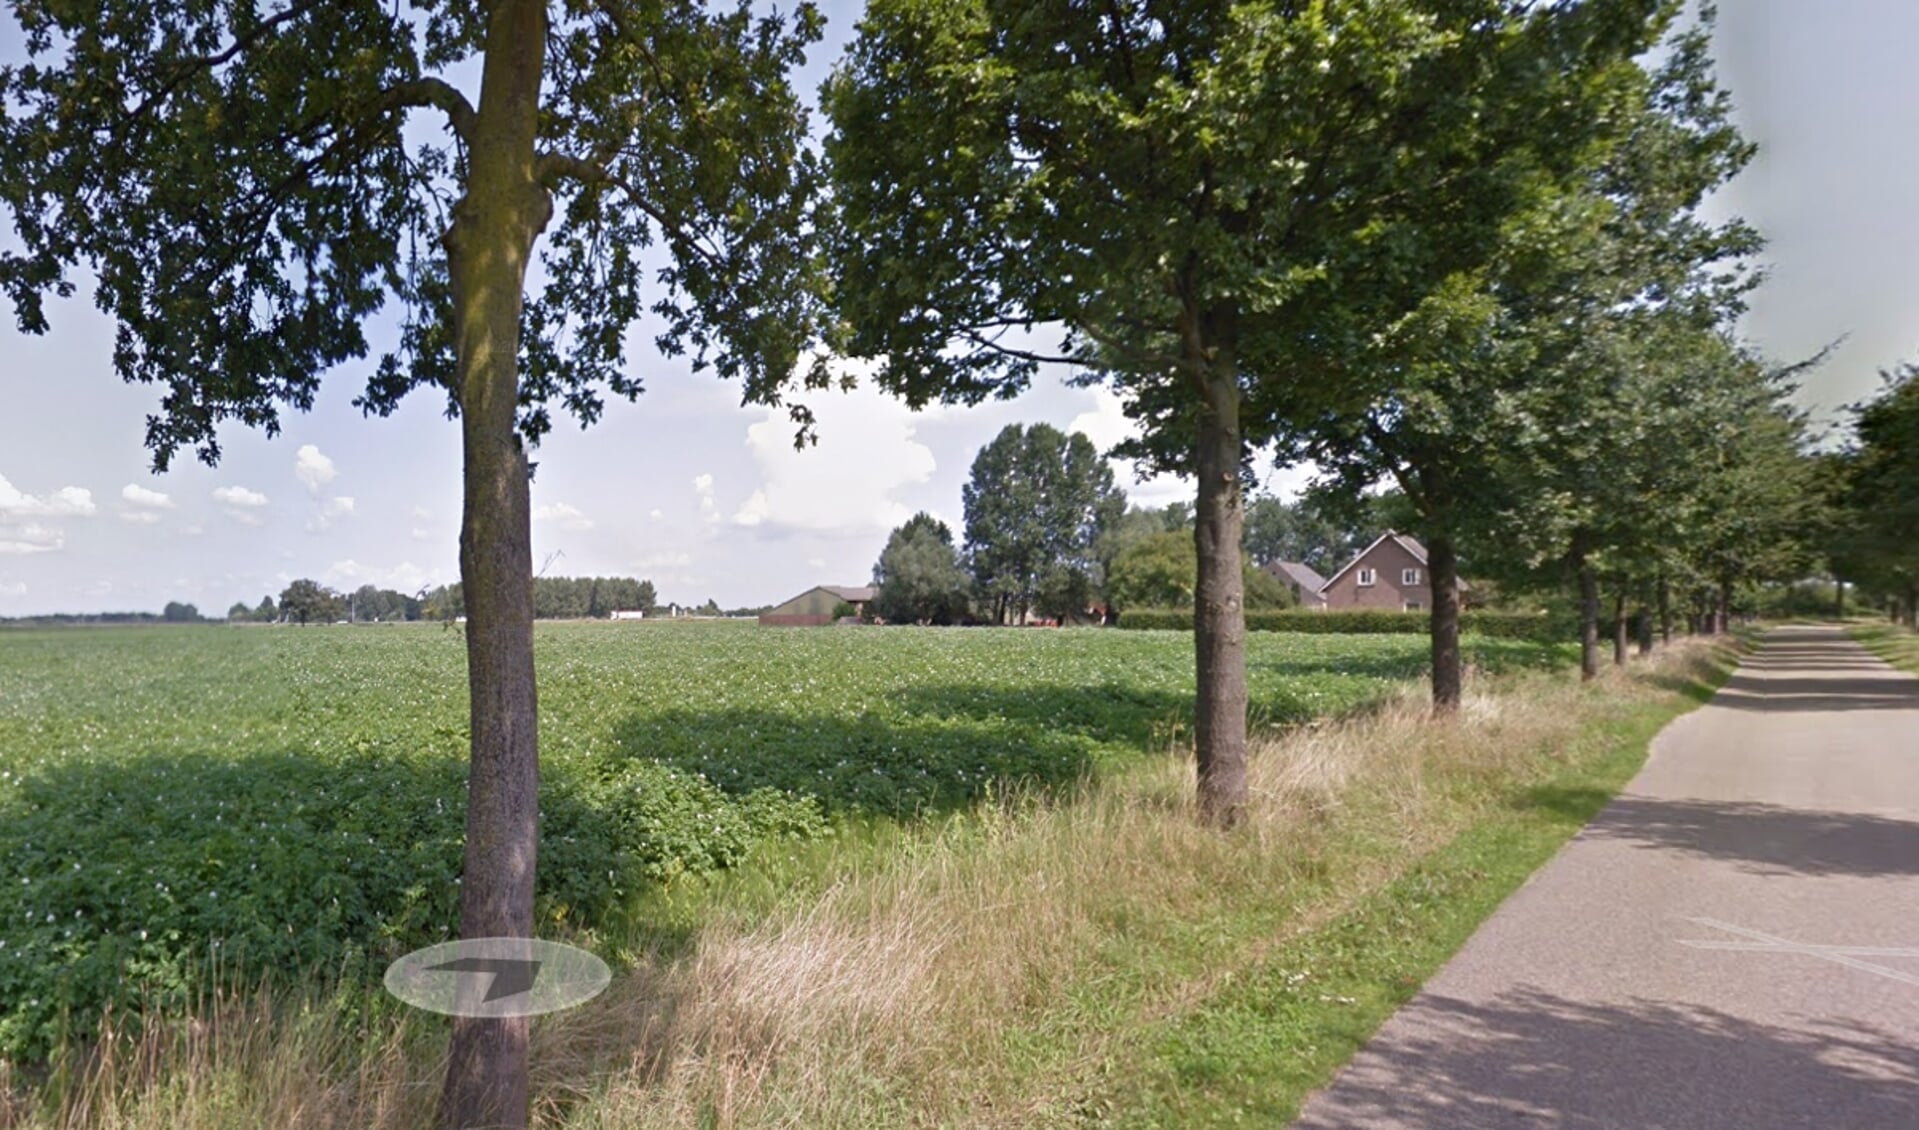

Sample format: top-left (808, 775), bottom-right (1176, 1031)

top-left (825, 0), bottom-right (1660, 823)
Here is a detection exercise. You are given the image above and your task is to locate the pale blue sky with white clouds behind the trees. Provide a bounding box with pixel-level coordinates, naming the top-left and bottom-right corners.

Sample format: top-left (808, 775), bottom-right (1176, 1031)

top-left (0, 0), bottom-right (1919, 616)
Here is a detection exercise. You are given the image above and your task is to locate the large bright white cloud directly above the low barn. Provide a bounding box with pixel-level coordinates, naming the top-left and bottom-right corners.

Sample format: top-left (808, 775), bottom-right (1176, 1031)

top-left (733, 379), bottom-right (936, 533)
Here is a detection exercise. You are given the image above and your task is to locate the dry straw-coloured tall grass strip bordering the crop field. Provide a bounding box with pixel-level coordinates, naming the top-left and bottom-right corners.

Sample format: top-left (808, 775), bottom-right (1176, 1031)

top-left (0, 633), bottom-right (1734, 1130)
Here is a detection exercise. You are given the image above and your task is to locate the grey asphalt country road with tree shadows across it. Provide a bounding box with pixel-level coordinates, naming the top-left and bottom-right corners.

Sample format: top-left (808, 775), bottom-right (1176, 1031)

top-left (1295, 627), bottom-right (1919, 1130)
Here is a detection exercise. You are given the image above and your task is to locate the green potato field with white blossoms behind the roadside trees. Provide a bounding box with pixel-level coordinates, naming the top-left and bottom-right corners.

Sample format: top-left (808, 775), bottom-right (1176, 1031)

top-left (0, 624), bottom-right (1564, 1059)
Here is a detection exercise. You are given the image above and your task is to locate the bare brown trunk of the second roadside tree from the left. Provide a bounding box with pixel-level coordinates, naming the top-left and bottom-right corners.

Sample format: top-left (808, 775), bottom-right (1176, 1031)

top-left (1186, 315), bottom-right (1247, 827)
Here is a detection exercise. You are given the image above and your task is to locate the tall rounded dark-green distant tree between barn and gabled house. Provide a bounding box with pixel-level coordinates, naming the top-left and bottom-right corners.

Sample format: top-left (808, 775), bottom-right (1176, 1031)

top-left (960, 424), bottom-right (1126, 624)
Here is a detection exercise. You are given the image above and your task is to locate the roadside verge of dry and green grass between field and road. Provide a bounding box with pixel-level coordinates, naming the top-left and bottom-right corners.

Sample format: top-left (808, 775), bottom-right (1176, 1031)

top-left (0, 645), bottom-right (1727, 1128)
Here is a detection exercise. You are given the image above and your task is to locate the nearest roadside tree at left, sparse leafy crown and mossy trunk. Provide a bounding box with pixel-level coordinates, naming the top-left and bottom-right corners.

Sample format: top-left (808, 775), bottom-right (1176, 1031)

top-left (0, 0), bottom-right (821, 1126)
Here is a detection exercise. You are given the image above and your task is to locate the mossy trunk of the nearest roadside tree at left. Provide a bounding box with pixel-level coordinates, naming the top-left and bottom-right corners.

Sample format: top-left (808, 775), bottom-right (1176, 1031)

top-left (439, 0), bottom-right (553, 1130)
